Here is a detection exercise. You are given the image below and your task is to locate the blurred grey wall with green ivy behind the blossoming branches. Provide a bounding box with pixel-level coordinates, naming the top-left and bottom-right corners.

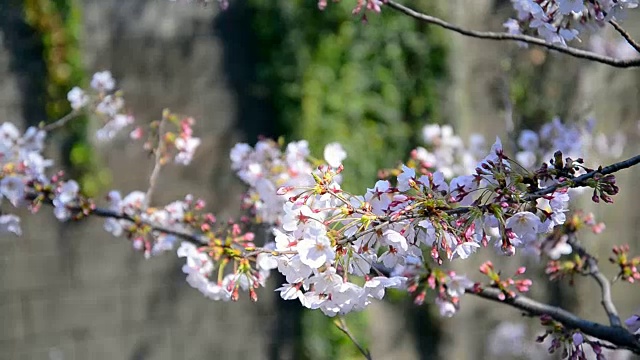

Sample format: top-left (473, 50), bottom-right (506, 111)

top-left (0, 0), bottom-right (640, 360)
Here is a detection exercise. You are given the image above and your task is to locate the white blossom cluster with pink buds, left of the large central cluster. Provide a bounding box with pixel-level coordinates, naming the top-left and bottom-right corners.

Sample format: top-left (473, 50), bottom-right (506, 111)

top-left (104, 191), bottom-right (264, 301)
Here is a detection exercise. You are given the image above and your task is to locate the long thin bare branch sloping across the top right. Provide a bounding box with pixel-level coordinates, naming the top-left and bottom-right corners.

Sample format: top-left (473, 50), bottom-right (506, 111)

top-left (384, 0), bottom-right (640, 68)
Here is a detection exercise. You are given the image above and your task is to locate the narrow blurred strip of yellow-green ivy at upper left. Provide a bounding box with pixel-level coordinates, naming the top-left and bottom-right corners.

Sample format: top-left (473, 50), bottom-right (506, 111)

top-left (23, 0), bottom-right (109, 196)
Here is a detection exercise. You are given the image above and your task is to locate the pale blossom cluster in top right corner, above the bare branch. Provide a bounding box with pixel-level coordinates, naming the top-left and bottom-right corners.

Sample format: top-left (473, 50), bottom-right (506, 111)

top-left (504, 0), bottom-right (638, 46)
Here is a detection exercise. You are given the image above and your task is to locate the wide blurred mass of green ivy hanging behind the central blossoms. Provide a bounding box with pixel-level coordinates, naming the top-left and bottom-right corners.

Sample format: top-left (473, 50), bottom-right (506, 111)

top-left (250, 0), bottom-right (446, 191)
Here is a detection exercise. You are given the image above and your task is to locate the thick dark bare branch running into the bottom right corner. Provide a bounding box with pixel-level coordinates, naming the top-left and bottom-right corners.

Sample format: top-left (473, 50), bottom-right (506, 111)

top-left (467, 288), bottom-right (640, 354)
